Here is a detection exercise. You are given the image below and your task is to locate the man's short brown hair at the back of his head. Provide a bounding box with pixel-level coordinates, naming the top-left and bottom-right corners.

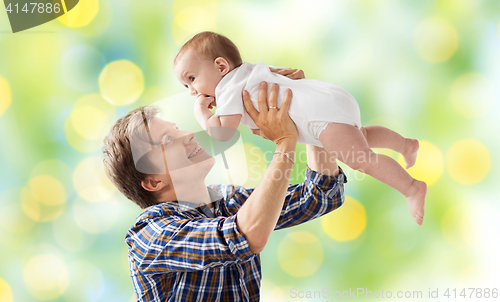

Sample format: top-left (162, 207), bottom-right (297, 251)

top-left (103, 106), bottom-right (159, 209)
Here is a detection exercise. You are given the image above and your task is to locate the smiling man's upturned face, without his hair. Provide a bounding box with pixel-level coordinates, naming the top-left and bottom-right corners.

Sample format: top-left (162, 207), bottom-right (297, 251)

top-left (145, 117), bottom-right (215, 180)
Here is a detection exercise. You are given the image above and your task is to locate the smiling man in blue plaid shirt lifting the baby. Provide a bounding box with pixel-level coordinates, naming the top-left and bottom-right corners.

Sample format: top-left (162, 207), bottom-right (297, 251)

top-left (104, 83), bottom-right (345, 301)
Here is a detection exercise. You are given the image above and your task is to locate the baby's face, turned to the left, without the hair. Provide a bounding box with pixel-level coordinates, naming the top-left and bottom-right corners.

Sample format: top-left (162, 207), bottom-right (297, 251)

top-left (174, 49), bottom-right (222, 97)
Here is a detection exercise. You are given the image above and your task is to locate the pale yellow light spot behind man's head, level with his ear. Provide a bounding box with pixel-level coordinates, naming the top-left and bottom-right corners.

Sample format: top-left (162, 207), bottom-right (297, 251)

top-left (73, 157), bottom-right (116, 202)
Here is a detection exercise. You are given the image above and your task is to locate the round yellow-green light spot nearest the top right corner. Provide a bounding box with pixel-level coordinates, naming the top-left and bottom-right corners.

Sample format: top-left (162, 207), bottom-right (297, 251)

top-left (413, 18), bottom-right (458, 63)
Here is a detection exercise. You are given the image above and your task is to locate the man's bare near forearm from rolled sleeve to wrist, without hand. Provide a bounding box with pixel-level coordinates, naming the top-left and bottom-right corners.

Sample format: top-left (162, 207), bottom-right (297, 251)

top-left (237, 141), bottom-right (296, 253)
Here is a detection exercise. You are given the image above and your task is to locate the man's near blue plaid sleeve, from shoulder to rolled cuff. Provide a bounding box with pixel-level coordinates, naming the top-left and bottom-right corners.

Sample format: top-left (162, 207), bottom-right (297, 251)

top-left (126, 215), bottom-right (255, 274)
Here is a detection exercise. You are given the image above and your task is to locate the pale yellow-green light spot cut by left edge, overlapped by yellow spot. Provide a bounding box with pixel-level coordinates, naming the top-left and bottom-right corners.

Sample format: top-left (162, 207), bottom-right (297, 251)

top-left (0, 188), bottom-right (35, 234)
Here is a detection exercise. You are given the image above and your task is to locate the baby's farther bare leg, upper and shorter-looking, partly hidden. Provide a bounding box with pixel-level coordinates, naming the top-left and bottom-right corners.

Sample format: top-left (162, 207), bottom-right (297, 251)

top-left (360, 126), bottom-right (419, 169)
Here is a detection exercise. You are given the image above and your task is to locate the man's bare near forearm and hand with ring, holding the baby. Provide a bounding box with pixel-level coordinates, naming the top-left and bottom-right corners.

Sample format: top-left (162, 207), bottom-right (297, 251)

top-left (236, 82), bottom-right (298, 253)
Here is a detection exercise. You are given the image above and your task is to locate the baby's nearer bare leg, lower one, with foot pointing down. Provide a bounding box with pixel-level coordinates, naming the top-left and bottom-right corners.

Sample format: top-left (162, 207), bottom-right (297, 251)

top-left (319, 123), bottom-right (427, 224)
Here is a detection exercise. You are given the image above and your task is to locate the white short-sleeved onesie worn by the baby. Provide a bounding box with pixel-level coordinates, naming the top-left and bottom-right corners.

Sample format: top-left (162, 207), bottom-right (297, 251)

top-left (215, 62), bottom-right (361, 147)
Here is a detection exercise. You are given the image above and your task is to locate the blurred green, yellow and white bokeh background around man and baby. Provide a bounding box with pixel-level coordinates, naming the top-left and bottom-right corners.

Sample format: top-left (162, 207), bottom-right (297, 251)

top-left (0, 0), bottom-right (500, 302)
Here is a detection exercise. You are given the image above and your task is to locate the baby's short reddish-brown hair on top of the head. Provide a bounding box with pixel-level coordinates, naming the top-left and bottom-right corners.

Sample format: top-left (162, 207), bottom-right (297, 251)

top-left (174, 31), bottom-right (243, 68)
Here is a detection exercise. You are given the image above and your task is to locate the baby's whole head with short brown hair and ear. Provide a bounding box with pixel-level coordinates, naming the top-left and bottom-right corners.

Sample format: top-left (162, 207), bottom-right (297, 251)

top-left (174, 31), bottom-right (243, 97)
